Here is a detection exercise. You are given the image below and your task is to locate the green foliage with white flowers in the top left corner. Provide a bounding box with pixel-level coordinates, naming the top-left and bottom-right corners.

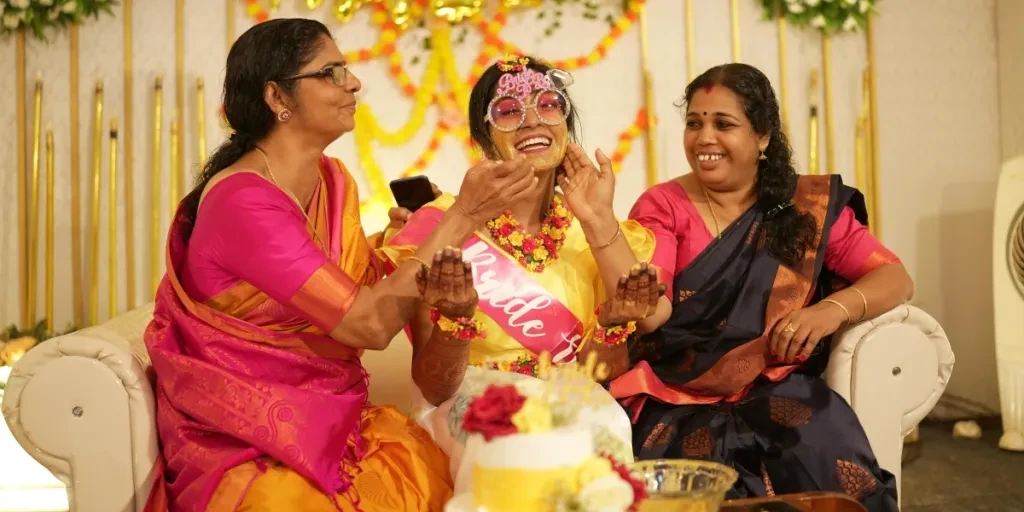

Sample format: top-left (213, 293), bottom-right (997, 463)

top-left (0, 0), bottom-right (117, 41)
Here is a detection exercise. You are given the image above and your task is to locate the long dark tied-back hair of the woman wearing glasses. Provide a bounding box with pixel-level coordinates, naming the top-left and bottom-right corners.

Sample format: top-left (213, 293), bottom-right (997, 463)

top-left (182, 18), bottom-right (331, 240)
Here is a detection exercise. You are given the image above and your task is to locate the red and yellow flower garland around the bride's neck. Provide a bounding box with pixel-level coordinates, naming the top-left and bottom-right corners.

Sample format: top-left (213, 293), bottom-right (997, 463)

top-left (487, 196), bottom-right (572, 272)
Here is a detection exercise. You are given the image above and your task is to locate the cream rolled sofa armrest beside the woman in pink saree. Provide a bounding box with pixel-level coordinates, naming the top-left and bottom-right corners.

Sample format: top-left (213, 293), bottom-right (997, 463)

top-left (3, 330), bottom-right (159, 512)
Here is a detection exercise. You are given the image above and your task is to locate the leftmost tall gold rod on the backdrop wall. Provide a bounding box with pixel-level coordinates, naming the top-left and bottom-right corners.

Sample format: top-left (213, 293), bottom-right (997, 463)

top-left (14, 31), bottom-right (27, 329)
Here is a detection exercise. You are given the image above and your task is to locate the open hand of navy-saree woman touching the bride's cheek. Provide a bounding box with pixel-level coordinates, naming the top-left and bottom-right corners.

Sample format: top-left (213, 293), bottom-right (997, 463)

top-left (558, 143), bottom-right (615, 223)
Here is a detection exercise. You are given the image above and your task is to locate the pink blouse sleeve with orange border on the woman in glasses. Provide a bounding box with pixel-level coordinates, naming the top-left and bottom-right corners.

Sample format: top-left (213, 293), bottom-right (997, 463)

top-left (197, 173), bottom-right (359, 332)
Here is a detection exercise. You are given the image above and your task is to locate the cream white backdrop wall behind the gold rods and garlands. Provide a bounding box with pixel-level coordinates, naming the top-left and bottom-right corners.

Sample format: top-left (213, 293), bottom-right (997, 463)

top-left (0, 0), bottom-right (999, 406)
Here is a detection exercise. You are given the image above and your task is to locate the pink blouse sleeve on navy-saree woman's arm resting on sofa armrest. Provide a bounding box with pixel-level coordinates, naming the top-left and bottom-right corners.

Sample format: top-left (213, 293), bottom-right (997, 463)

top-left (824, 207), bottom-right (899, 283)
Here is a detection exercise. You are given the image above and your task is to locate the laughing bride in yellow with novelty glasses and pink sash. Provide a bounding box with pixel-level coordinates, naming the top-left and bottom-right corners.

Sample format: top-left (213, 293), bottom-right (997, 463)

top-left (383, 56), bottom-right (664, 494)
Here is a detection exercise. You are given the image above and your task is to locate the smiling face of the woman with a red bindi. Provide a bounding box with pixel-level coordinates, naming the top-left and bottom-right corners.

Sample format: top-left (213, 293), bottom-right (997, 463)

top-left (683, 86), bottom-right (770, 190)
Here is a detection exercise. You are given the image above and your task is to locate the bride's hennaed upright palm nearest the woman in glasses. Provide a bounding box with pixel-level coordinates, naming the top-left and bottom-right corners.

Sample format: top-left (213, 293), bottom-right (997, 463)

top-left (416, 247), bottom-right (479, 319)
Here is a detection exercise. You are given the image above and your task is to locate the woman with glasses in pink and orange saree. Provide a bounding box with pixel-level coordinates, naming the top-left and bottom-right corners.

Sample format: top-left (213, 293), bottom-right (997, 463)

top-left (145, 19), bottom-right (536, 511)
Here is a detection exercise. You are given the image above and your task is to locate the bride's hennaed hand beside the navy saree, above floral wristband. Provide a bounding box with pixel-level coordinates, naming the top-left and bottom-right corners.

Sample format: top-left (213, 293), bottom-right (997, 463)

top-left (597, 263), bottom-right (667, 327)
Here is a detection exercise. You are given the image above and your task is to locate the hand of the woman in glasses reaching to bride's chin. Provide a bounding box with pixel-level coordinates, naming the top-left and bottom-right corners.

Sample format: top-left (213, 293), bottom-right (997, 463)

top-left (452, 155), bottom-right (539, 224)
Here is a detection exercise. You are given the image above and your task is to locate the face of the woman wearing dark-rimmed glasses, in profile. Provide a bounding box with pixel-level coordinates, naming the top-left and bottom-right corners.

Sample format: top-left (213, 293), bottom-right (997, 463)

top-left (275, 37), bottom-right (362, 140)
